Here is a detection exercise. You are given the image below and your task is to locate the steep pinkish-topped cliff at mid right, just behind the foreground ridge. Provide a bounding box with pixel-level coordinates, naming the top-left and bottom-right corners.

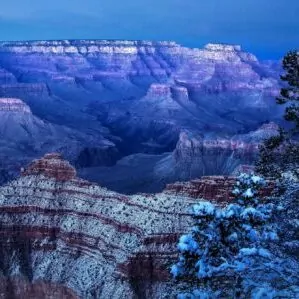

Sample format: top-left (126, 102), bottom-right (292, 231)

top-left (172, 123), bottom-right (278, 180)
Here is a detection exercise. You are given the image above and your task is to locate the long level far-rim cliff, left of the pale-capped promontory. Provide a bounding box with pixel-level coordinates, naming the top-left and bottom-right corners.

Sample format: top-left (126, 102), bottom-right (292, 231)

top-left (0, 40), bottom-right (182, 83)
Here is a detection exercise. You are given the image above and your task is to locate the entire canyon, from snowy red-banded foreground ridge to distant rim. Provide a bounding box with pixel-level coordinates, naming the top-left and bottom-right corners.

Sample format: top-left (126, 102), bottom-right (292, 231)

top-left (0, 40), bottom-right (298, 299)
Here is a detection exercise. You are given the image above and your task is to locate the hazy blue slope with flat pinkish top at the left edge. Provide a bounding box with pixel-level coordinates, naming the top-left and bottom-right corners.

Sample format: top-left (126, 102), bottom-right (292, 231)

top-left (0, 98), bottom-right (114, 182)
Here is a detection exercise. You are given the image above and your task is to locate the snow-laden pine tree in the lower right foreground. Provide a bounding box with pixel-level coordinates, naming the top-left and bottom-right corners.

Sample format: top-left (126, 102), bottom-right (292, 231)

top-left (171, 174), bottom-right (288, 298)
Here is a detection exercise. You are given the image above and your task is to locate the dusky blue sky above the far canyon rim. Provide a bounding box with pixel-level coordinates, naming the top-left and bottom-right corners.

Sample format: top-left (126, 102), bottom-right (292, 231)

top-left (0, 0), bottom-right (299, 59)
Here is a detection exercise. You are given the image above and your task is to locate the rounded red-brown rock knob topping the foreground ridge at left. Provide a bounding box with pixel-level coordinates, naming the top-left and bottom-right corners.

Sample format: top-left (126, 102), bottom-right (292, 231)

top-left (21, 153), bottom-right (76, 181)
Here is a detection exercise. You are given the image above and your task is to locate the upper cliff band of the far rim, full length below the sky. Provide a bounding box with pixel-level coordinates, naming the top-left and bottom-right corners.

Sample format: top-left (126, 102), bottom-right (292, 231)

top-left (0, 40), bottom-right (277, 92)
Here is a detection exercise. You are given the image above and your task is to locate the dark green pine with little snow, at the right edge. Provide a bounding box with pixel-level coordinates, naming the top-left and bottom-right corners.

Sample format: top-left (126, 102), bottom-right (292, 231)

top-left (256, 51), bottom-right (299, 179)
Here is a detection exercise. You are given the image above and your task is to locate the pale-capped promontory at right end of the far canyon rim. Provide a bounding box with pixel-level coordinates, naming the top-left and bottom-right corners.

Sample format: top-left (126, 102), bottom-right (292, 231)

top-left (175, 44), bottom-right (279, 95)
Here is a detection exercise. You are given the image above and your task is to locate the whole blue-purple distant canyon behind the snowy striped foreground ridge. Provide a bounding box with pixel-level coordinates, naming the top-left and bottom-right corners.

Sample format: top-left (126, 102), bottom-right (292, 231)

top-left (0, 40), bottom-right (282, 194)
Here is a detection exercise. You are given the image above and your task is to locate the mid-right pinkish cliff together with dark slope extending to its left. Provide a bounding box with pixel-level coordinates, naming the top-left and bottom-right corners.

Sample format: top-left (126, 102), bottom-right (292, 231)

top-left (79, 123), bottom-right (278, 194)
